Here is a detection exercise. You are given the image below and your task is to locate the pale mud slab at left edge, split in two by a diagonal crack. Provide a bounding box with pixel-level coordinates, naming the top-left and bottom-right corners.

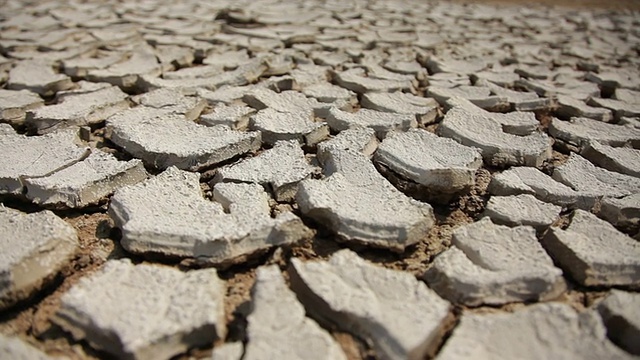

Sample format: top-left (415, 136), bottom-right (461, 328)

top-left (0, 122), bottom-right (147, 208)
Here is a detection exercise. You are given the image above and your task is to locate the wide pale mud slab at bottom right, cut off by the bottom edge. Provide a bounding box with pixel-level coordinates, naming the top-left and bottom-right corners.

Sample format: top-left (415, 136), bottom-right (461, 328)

top-left (438, 303), bottom-right (633, 360)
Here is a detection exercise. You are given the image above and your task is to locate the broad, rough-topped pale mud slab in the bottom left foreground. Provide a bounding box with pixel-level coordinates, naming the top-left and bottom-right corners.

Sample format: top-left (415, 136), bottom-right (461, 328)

top-left (54, 259), bottom-right (226, 359)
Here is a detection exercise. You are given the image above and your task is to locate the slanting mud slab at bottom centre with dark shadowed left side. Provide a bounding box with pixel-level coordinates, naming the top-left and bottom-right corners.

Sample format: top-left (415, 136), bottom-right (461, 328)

top-left (289, 250), bottom-right (450, 359)
